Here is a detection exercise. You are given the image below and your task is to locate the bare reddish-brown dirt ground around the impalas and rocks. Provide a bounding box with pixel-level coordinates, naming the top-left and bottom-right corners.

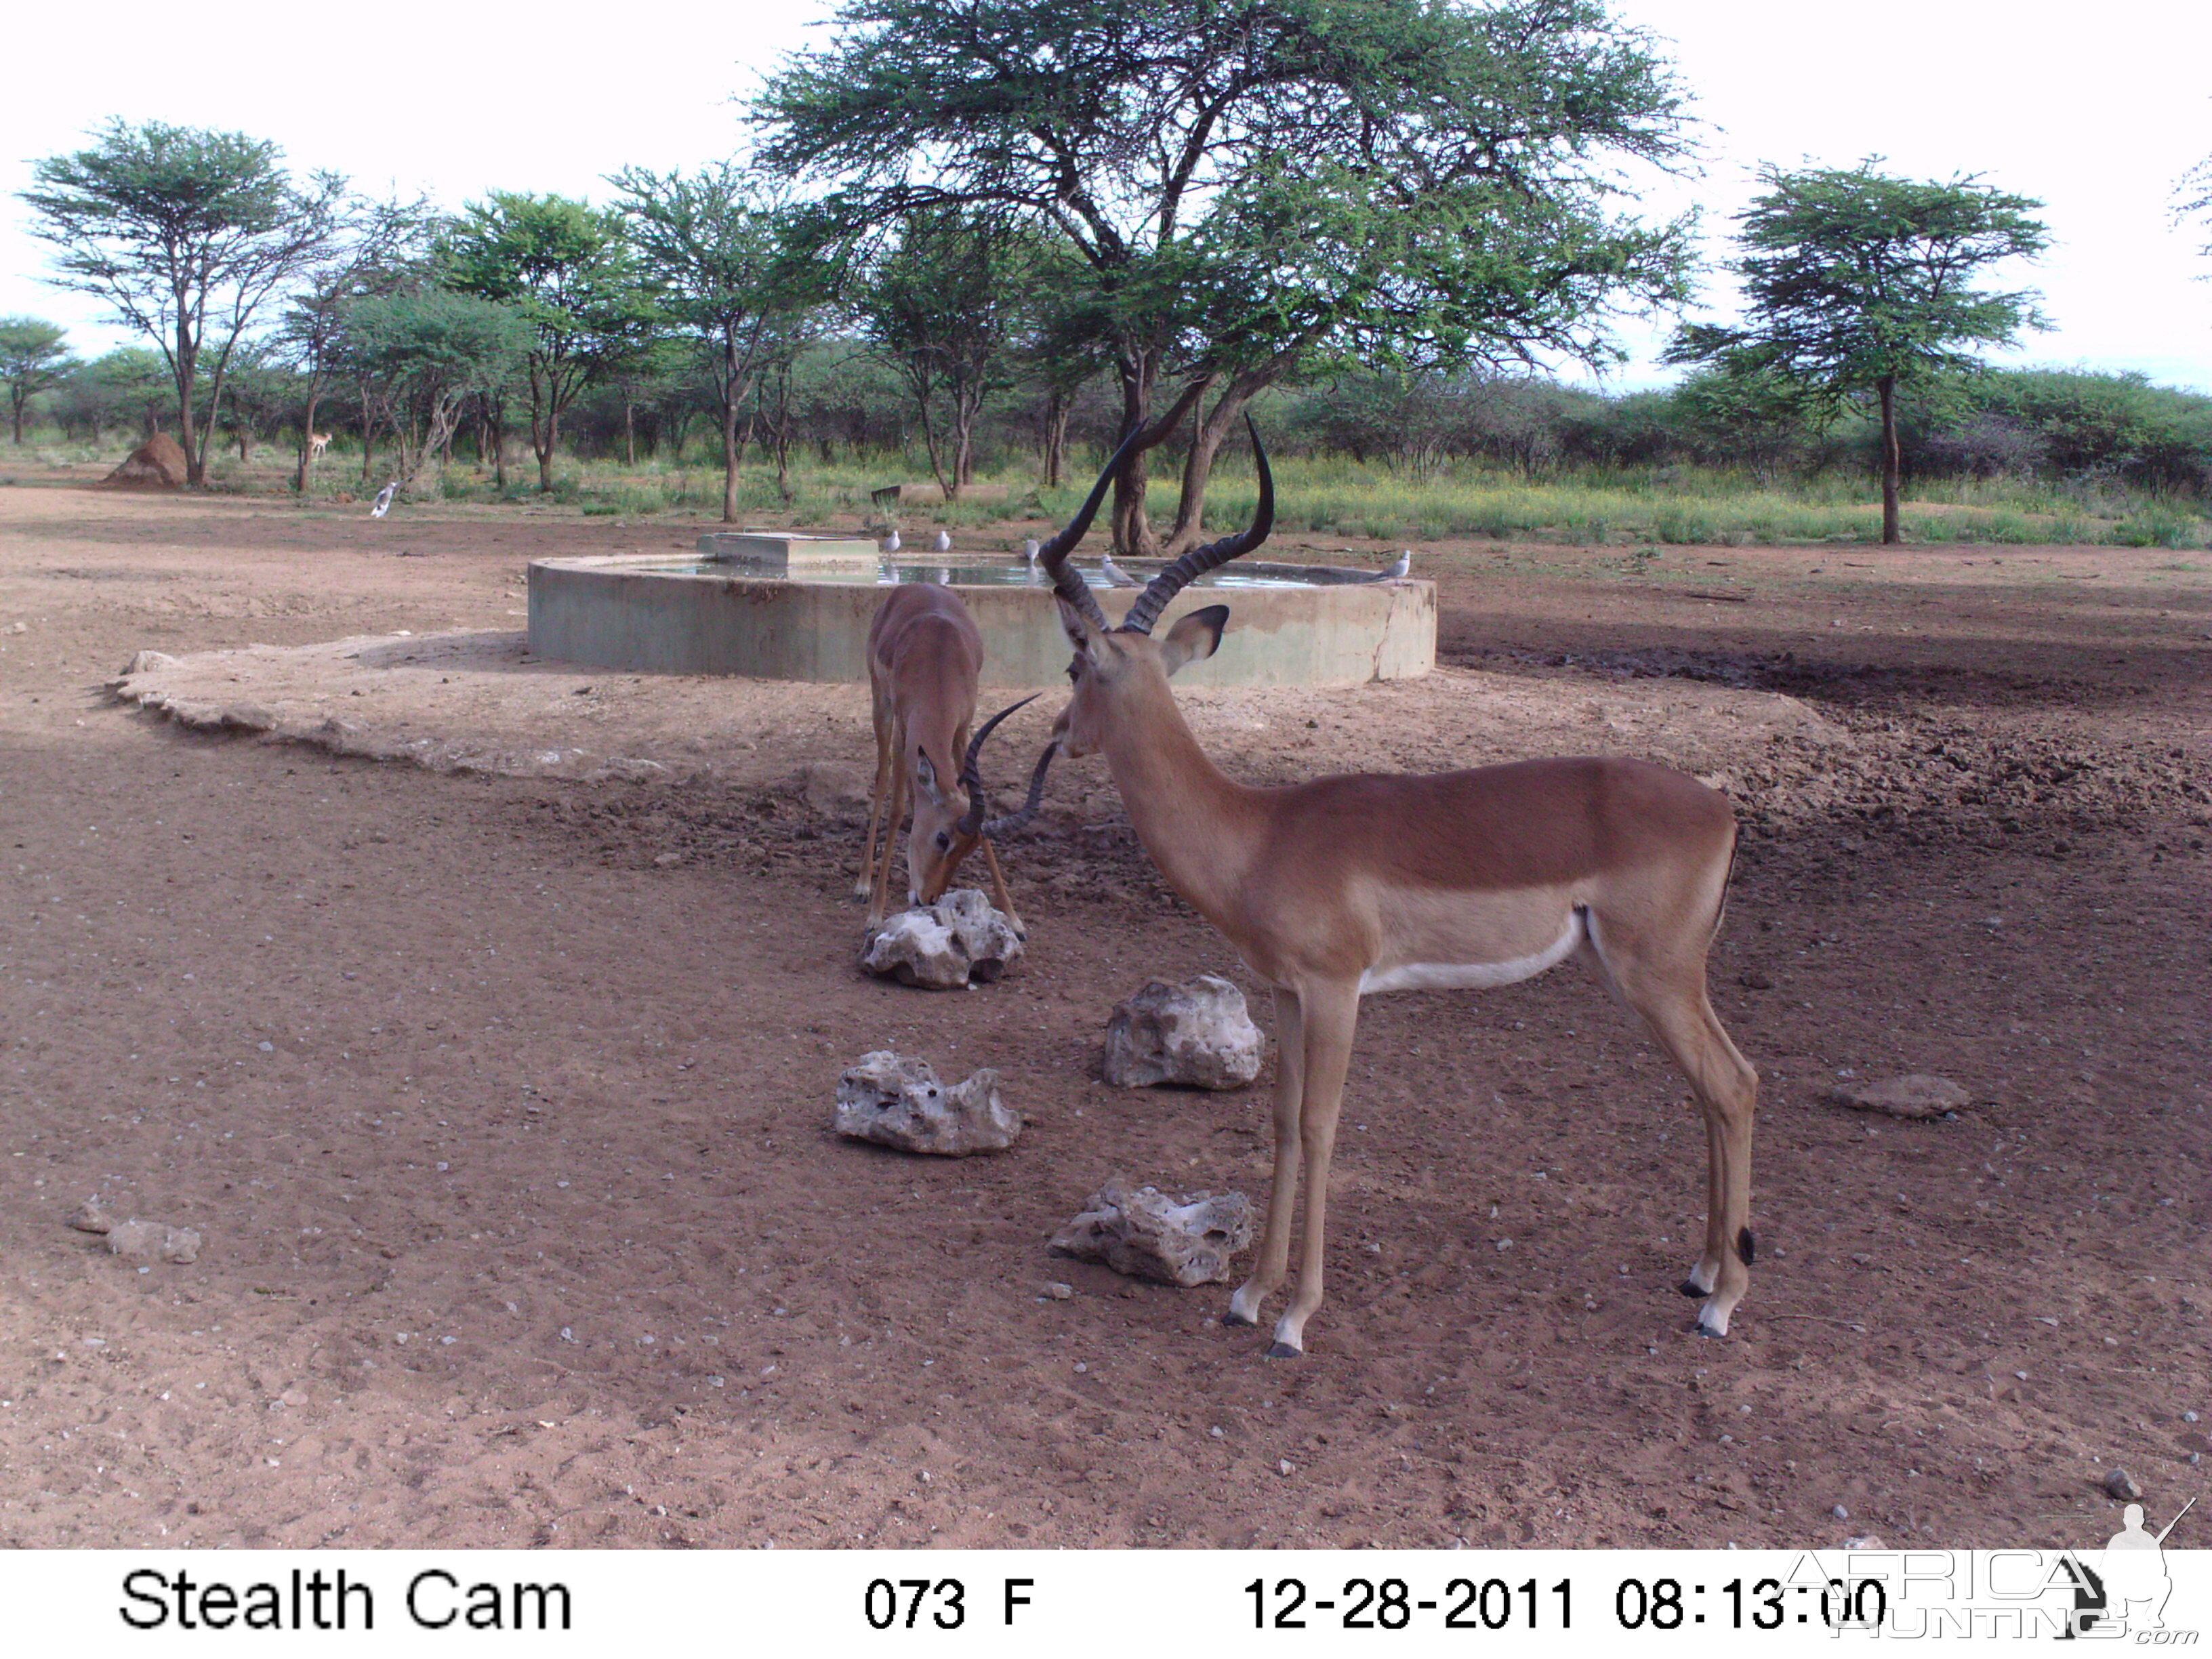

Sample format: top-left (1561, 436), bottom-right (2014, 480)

top-left (0, 471), bottom-right (2212, 1549)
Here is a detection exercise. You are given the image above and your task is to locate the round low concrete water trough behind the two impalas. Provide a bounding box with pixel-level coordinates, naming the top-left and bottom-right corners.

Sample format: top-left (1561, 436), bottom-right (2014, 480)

top-left (529, 533), bottom-right (1435, 688)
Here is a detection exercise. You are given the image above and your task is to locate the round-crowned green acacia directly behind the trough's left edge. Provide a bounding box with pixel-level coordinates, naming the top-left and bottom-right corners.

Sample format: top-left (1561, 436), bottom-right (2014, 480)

top-left (441, 190), bottom-right (653, 491)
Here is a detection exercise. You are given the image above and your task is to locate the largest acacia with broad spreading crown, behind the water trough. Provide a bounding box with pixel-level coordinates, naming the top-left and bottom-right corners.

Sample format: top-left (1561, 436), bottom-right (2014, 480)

top-left (754, 0), bottom-right (1687, 551)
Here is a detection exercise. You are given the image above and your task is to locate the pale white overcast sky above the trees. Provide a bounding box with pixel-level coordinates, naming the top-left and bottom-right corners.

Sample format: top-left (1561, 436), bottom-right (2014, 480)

top-left (0, 0), bottom-right (2212, 392)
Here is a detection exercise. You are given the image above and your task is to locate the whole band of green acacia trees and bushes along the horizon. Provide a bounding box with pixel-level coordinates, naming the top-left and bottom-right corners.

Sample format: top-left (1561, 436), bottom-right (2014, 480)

top-left (13, 0), bottom-right (2212, 555)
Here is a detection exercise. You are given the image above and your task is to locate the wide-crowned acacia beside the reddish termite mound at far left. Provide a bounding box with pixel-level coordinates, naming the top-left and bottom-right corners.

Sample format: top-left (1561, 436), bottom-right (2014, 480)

top-left (22, 119), bottom-right (345, 485)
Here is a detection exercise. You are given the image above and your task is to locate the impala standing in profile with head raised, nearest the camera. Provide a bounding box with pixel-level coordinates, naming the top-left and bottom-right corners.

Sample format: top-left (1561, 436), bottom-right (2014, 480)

top-left (1040, 431), bottom-right (1759, 1358)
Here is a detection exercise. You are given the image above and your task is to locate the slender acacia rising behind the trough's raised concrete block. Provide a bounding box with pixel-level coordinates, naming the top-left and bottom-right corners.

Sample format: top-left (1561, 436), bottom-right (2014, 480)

top-left (609, 161), bottom-right (812, 525)
